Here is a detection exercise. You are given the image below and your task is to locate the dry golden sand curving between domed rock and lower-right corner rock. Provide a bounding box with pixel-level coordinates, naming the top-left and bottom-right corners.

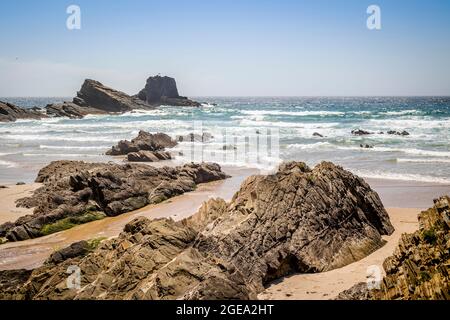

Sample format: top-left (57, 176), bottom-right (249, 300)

top-left (258, 208), bottom-right (420, 300)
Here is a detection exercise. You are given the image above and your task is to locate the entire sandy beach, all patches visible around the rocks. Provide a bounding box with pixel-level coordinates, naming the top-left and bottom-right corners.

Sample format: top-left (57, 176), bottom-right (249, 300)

top-left (0, 167), bottom-right (450, 299)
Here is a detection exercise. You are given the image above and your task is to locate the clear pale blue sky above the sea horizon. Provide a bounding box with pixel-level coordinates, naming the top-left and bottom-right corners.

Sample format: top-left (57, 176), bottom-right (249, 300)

top-left (0, 0), bottom-right (450, 96)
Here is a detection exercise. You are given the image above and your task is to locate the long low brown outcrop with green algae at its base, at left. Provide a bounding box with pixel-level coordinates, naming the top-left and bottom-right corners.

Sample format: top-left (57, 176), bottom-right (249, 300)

top-left (0, 161), bottom-right (227, 241)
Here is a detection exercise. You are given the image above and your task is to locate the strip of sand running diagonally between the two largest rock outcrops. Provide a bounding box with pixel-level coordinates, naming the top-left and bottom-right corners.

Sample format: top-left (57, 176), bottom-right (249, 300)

top-left (0, 168), bottom-right (257, 270)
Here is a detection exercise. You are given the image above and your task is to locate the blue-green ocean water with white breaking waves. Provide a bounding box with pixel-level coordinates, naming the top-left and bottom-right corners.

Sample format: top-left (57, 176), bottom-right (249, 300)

top-left (0, 97), bottom-right (450, 184)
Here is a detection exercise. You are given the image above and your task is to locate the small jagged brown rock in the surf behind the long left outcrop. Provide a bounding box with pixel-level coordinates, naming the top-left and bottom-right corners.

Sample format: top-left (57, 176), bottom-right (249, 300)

top-left (106, 130), bottom-right (177, 156)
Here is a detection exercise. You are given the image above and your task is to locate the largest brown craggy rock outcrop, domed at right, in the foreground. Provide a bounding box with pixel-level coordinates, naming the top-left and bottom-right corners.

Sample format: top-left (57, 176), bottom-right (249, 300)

top-left (0, 162), bottom-right (393, 299)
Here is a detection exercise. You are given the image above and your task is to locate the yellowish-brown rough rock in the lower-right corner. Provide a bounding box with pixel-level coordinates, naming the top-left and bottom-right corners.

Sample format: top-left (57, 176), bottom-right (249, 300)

top-left (338, 196), bottom-right (450, 300)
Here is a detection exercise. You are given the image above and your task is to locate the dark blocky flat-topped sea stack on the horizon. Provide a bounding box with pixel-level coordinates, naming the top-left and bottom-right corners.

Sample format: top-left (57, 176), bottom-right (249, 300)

top-left (137, 75), bottom-right (201, 107)
